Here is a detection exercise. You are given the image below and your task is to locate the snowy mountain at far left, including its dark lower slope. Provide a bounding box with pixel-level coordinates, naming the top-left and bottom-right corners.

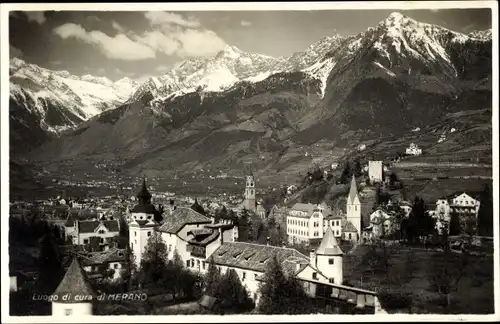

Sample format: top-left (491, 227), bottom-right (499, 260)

top-left (9, 58), bottom-right (138, 151)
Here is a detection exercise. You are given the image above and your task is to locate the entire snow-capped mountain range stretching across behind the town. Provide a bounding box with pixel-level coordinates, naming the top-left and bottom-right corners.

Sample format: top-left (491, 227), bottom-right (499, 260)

top-left (10, 13), bottom-right (492, 187)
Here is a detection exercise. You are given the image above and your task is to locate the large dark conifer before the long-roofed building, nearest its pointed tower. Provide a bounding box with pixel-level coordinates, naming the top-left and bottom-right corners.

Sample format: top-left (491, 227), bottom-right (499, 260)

top-left (257, 255), bottom-right (307, 314)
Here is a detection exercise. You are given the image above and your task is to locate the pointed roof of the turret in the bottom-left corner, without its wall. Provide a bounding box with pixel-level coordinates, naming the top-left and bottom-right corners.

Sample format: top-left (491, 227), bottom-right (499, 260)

top-left (54, 257), bottom-right (96, 303)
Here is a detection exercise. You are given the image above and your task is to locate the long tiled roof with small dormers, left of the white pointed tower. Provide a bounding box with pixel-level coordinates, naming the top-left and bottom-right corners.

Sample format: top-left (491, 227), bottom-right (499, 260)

top-left (212, 242), bottom-right (309, 273)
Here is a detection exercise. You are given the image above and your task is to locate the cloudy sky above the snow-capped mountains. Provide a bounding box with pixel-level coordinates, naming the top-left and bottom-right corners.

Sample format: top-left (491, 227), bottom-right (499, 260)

top-left (9, 9), bottom-right (492, 80)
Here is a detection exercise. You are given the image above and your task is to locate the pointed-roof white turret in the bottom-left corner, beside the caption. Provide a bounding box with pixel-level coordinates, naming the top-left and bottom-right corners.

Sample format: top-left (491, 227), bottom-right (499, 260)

top-left (52, 256), bottom-right (97, 316)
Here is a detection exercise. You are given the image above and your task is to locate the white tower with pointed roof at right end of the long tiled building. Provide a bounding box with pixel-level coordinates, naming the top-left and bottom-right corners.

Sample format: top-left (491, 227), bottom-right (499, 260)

top-left (311, 226), bottom-right (344, 285)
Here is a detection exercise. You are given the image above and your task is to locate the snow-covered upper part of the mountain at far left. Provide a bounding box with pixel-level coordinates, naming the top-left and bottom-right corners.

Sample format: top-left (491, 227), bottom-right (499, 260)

top-left (10, 58), bottom-right (137, 133)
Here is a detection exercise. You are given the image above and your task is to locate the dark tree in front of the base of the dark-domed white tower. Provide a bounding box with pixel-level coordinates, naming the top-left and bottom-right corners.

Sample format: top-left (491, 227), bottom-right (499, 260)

top-left (139, 231), bottom-right (167, 286)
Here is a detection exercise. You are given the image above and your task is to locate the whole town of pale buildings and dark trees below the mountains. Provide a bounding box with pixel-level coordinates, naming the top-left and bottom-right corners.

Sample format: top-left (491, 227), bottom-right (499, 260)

top-left (9, 155), bottom-right (493, 316)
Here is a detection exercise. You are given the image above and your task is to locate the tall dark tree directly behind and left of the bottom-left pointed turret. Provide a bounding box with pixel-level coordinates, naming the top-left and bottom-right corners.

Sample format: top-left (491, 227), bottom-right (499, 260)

top-left (36, 234), bottom-right (65, 295)
